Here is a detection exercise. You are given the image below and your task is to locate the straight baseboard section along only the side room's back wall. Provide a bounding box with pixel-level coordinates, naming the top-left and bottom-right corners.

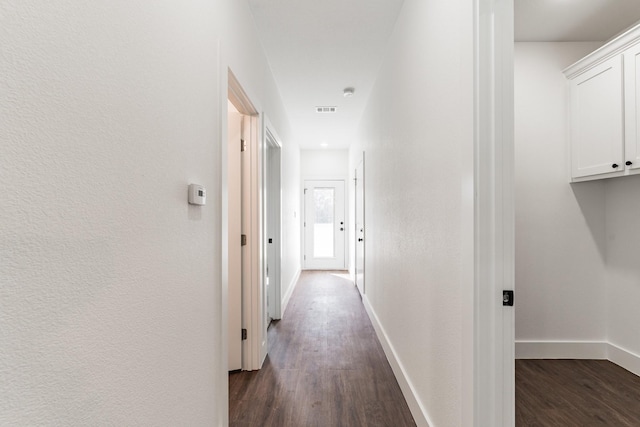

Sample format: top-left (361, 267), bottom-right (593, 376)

top-left (516, 341), bottom-right (607, 360)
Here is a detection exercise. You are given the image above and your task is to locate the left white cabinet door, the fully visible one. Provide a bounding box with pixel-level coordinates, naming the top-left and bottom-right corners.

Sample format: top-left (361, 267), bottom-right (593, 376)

top-left (570, 56), bottom-right (624, 178)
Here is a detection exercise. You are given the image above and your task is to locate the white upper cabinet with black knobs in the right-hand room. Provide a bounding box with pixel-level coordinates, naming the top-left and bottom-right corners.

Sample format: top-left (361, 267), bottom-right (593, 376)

top-left (564, 26), bottom-right (640, 182)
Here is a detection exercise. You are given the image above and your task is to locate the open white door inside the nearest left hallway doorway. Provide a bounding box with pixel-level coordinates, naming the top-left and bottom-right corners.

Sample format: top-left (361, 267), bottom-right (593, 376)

top-left (227, 103), bottom-right (242, 371)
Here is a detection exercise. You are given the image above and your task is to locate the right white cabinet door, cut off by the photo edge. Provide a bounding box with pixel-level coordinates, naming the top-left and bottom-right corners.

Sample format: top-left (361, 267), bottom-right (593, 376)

top-left (624, 43), bottom-right (640, 172)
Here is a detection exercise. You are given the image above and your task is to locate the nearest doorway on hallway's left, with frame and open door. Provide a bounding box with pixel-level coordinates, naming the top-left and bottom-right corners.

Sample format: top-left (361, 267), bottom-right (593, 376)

top-left (223, 70), bottom-right (267, 371)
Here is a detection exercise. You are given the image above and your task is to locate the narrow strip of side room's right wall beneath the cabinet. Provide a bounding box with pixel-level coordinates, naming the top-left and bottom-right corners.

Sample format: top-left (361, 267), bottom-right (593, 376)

top-left (606, 176), bottom-right (640, 358)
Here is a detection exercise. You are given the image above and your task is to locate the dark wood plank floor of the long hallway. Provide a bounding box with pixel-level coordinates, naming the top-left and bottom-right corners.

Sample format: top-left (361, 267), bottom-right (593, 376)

top-left (229, 271), bottom-right (415, 427)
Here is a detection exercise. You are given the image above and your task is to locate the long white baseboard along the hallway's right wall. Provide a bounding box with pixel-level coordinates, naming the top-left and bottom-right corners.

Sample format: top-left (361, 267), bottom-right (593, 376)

top-left (362, 295), bottom-right (434, 427)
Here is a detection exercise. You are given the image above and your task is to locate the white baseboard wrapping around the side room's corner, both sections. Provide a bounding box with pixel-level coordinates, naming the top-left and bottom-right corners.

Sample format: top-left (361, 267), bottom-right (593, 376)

top-left (516, 341), bottom-right (640, 376)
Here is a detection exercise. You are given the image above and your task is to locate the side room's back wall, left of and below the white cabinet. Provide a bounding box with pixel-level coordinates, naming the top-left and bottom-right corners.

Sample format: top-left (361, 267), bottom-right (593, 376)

top-left (514, 43), bottom-right (606, 341)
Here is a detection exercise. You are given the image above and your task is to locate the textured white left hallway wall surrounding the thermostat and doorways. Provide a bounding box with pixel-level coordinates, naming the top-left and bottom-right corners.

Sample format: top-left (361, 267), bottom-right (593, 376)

top-left (0, 0), bottom-right (299, 425)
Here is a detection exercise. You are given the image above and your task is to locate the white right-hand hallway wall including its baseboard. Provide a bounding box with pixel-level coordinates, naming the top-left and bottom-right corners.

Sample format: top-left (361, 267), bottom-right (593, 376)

top-left (349, 0), bottom-right (473, 426)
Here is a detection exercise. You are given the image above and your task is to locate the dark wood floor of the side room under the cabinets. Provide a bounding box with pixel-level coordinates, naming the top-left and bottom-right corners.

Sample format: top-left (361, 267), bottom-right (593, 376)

top-left (516, 360), bottom-right (640, 427)
